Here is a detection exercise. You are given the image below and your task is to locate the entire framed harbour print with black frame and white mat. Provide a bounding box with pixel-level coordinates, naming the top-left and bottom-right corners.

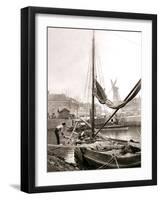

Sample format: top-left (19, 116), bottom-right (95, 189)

top-left (21, 7), bottom-right (157, 193)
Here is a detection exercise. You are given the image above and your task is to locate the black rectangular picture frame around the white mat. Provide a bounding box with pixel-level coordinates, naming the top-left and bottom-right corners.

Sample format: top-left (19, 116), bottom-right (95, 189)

top-left (21, 7), bottom-right (157, 193)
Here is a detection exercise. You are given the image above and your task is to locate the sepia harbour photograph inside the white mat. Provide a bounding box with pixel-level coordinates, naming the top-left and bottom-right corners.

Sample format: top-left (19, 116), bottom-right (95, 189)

top-left (47, 27), bottom-right (142, 172)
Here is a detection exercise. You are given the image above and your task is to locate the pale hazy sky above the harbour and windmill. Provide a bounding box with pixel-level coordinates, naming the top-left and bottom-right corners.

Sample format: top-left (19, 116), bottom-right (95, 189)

top-left (48, 28), bottom-right (141, 100)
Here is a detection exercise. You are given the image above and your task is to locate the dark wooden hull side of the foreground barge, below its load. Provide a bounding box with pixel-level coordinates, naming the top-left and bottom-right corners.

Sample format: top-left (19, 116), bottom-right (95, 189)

top-left (75, 148), bottom-right (141, 169)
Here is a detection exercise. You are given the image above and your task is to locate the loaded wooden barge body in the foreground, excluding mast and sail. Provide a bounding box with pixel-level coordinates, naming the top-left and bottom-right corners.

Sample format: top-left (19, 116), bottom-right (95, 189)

top-left (74, 141), bottom-right (141, 169)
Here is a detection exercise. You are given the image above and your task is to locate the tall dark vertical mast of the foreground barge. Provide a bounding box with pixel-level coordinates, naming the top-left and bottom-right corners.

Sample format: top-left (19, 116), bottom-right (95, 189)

top-left (91, 31), bottom-right (95, 137)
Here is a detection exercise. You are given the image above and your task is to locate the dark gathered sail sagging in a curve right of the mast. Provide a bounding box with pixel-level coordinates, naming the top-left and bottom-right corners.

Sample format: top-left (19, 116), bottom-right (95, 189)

top-left (94, 79), bottom-right (141, 109)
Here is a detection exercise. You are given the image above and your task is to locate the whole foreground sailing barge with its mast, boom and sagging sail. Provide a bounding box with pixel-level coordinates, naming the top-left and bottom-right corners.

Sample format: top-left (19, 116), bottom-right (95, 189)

top-left (74, 32), bottom-right (141, 169)
